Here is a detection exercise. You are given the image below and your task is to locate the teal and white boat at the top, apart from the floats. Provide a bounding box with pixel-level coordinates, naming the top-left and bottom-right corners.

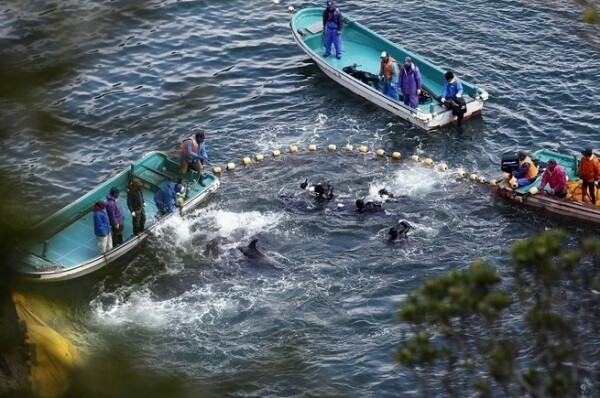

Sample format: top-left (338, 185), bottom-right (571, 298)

top-left (290, 8), bottom-right (488, 130)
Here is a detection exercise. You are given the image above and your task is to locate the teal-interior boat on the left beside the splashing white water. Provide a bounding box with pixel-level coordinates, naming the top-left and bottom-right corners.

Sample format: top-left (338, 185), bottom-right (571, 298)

top-left (13, 152), bottom-right (220, 282)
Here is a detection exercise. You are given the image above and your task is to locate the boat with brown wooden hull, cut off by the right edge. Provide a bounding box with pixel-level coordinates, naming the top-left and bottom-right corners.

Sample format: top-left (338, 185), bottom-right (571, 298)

top-left (491, 149), bottom-right (600, 224)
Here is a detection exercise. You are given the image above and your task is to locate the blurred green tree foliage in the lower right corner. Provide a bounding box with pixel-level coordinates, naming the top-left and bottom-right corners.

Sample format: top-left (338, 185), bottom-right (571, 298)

top-left (397, 230), bottom-right (600, 397)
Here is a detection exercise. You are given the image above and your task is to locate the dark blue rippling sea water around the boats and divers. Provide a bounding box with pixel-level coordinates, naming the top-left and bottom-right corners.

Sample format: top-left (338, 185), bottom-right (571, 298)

top-left (0, 0), bottom-right (600, 397)
